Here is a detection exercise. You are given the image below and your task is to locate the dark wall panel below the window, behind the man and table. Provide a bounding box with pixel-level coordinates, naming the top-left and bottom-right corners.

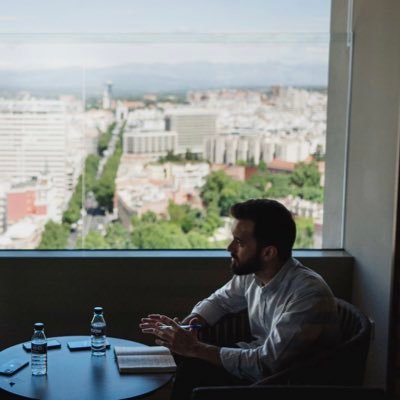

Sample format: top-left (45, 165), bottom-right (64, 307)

top-left (0, 252), bottom-right (353, 350)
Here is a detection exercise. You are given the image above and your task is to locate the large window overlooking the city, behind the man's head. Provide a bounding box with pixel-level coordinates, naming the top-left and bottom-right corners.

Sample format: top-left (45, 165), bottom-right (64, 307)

top-left (0, 0), bottom-right (330, 249)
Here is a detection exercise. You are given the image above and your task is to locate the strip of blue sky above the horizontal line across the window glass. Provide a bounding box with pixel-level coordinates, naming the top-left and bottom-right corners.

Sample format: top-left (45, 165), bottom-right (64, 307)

top-left (0, 0), bottom-right (331, 33)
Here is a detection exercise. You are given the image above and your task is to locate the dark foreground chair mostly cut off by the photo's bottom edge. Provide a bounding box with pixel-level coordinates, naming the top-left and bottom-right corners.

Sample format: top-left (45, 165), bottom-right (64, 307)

top-left (191, 385), bottom-right (389, 400)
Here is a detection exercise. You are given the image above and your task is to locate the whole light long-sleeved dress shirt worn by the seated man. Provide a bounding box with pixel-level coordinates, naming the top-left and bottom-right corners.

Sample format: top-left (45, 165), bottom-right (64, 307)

top-left (192, 258), bottom-right (340, 381)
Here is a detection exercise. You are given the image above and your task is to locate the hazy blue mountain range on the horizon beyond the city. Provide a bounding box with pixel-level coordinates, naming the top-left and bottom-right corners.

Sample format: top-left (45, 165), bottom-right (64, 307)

top-left (0, 62), bottom-right (327, 97)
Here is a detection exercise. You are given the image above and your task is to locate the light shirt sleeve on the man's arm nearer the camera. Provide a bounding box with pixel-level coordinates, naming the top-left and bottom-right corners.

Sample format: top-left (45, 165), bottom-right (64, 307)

top-left (220, 293), bottom-right (338, 381)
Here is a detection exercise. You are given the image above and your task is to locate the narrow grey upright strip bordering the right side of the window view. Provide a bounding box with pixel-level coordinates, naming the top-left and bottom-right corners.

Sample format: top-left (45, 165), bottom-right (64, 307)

top-left (322, 0), bottom-right (351, 249)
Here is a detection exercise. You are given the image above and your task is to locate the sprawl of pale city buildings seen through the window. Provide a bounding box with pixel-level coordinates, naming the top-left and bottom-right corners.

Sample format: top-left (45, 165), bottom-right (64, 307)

top-left (0, 87), bottom-right (327, 248)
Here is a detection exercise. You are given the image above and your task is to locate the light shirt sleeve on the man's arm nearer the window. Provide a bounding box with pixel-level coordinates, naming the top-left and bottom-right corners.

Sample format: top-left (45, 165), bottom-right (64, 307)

top-left (192, 275), bottom-right (247, 325)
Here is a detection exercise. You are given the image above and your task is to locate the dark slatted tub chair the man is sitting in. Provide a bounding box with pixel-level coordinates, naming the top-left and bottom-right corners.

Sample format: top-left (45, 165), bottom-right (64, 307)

top-left (200, 298), bottom-right (372, 386)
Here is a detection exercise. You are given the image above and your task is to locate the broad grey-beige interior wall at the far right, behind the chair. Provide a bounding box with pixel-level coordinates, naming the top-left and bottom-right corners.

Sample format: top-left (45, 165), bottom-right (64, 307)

top-left (344, 0), bottom-right (400, 387)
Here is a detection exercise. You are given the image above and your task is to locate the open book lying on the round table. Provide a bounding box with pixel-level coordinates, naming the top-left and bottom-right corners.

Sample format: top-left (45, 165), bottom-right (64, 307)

top-left (114, 346), bottom-right (176, 373)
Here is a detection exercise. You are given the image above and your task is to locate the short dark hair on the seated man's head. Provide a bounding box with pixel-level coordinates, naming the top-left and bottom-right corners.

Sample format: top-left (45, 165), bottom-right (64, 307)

top-left (230, 199), bottom-right (296, 261)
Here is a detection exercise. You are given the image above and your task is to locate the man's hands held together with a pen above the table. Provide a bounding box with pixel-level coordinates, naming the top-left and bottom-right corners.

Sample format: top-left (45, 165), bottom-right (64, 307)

top-left (139, 314), bottom-right (200, 357)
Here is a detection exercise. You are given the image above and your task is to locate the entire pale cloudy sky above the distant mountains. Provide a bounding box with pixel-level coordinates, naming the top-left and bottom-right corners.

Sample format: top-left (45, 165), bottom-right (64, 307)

top-left (0, 0), bottom-right (331, 72)
